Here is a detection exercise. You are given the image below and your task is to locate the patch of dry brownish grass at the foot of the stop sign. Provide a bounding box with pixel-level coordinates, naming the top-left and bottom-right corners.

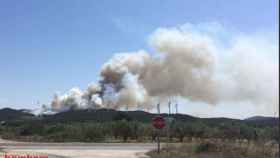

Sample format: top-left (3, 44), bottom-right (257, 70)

top-left (148, 141), bottom-right (279, 158)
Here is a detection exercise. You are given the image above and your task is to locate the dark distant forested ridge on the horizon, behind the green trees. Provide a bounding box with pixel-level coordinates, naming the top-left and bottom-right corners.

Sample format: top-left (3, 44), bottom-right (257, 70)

top-left (0, 108), bottom-right (279, 126)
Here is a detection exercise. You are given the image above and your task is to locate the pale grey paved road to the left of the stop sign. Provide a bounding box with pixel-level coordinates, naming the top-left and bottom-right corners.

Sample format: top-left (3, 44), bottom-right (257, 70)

top-left (0, 142), bottom-right (156, 158)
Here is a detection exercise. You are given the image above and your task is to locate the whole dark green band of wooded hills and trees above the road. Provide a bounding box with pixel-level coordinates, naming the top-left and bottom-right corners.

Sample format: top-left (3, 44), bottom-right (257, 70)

top-left (0, 110), bottom-right (279, 142)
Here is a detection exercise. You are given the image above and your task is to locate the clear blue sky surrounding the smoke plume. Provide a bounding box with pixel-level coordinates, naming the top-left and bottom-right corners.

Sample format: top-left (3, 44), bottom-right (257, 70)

top-left (0, 0), bottom-right (279, 117)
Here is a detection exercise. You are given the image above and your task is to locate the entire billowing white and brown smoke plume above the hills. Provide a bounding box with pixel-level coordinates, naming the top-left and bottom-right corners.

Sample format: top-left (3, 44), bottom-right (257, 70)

top-left (51, 24), bottom-right (279, 116)
